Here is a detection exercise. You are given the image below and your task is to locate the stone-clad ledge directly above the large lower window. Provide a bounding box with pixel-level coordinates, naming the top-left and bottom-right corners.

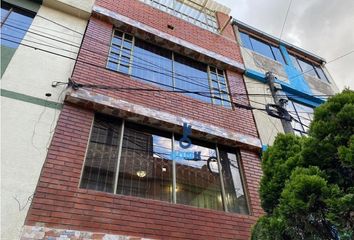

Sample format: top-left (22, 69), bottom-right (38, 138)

top-left (66, 89), bottom-right (262, 151)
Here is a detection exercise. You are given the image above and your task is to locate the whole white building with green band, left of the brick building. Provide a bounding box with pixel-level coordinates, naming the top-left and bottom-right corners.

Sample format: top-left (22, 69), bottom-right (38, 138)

top-left (1, 0), bottom-right (94, 240)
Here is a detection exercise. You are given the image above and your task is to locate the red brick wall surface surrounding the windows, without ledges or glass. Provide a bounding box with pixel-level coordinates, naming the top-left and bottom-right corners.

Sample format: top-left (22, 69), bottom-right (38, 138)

top-left (25, 0), bottom-right (263, 239)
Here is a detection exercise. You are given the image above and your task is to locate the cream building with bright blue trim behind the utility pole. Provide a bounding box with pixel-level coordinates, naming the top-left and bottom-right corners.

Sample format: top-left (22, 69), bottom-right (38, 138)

top-left (233, 20), bottom-right (338, 145)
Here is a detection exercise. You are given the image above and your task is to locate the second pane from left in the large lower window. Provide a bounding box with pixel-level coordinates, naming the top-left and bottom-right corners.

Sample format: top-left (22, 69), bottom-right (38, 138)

top-left (117, 123), bottom-right (172, 202)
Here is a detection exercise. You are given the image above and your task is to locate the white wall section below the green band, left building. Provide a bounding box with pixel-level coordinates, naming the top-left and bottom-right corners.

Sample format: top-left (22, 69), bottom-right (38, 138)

top-left (1, 97), bottom-right (59, 239)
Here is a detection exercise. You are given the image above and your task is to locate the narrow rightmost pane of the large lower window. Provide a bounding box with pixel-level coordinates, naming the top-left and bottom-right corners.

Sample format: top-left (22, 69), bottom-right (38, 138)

top-left (219, 149), bottom-right (248, 214)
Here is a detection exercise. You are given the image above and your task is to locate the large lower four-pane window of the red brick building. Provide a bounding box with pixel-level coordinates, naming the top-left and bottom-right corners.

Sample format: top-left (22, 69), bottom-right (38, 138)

top-left (80, 114), bottom-right (248, 214)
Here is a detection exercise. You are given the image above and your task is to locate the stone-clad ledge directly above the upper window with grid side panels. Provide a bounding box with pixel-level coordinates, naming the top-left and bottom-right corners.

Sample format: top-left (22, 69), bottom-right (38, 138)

top-left (92, 5), bottom-right (245, 72)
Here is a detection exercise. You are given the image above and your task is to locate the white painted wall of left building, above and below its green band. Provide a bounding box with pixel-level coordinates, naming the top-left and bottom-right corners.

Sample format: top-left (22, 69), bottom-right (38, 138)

top-left (1, 6), bottom-right (87, 240)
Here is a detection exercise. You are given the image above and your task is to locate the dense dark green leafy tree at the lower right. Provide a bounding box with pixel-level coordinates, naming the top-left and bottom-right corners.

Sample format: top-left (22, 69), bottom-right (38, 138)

top-left (252, 90), bottom-right (354, 240)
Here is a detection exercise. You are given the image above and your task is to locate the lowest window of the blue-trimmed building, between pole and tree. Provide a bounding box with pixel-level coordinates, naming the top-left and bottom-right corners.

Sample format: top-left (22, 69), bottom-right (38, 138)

top-left (287, 100), bottom-right (313, 136)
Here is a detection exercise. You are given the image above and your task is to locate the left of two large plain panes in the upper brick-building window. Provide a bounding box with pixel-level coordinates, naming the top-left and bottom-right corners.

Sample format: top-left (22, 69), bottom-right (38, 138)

top-left (132, 39), bottom-right (173, 89)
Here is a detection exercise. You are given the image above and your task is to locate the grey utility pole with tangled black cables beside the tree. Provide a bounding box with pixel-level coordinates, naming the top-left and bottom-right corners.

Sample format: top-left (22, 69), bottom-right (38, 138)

top-left (266, 72), bottom-right (294, 133)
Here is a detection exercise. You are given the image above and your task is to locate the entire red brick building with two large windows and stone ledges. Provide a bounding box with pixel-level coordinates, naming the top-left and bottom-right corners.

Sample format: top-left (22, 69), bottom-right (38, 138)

top-left (22, 0), bottom-right (262, 239)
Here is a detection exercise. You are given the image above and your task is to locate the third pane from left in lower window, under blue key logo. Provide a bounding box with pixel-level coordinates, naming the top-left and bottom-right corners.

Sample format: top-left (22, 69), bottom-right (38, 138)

top-left (174, 136), bottom-right (223, 210)
